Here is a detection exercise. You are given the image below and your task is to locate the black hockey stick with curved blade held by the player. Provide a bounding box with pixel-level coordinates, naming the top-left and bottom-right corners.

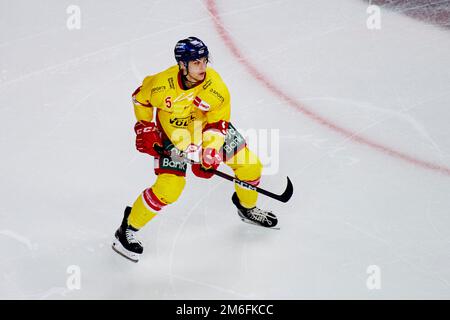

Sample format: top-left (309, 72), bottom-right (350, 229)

top-left (154, 145), bottom-right (294, 202)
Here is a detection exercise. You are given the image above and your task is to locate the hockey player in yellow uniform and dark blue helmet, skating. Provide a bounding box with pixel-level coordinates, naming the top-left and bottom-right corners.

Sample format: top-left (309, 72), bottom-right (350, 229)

top-left (113, 37), bottom-right (277, 262)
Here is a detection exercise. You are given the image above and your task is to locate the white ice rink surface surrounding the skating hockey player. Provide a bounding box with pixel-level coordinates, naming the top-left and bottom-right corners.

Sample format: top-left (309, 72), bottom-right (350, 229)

top-left (0, 0), bottom-right (450, 299)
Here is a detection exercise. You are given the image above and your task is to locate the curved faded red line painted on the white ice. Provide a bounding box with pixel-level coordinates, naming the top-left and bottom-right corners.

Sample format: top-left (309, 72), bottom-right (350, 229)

top-left (206, 0), bottom-right (450, 176)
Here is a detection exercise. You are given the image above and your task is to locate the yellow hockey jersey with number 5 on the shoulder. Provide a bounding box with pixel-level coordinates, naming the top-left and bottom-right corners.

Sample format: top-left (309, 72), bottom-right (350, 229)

top-left (132, 65), bottom-right (230, 151)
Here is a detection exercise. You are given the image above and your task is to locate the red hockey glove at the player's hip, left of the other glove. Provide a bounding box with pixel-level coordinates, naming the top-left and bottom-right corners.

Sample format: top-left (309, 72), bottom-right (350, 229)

top-left (134, 120), bottom-right (162, 157)
